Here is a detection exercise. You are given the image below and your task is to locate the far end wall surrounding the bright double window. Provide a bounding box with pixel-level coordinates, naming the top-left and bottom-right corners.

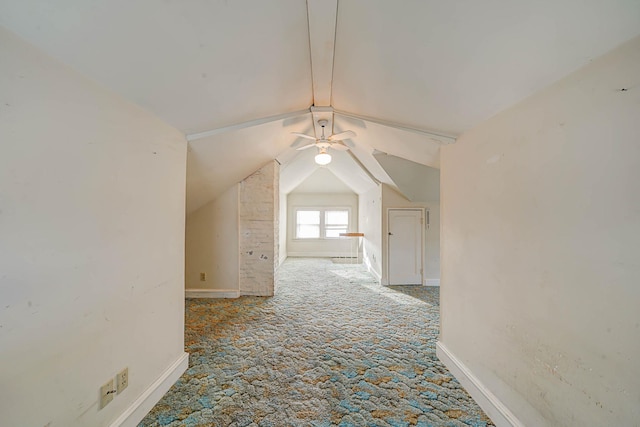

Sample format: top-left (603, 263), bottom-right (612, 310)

top-left (287, 192), bottom-right (358, 257)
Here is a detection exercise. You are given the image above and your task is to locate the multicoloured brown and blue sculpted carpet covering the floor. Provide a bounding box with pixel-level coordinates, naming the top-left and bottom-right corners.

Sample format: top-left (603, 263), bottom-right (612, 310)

top-left (139, 258), bottom-right (493, 427)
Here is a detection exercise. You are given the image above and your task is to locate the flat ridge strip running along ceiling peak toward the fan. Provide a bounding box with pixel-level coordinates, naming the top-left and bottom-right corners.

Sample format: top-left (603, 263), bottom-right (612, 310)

top-left (307, 0), bottom-right (338, 106)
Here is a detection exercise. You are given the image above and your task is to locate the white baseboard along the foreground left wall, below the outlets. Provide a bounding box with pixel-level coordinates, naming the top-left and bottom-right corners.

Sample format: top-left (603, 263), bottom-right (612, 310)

top-left (110, 353), bottom-right (189, 427)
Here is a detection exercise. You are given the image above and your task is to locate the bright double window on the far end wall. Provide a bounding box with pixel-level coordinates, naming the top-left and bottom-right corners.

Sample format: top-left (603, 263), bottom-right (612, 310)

top-left (296, 208), bottom-right (349, 239)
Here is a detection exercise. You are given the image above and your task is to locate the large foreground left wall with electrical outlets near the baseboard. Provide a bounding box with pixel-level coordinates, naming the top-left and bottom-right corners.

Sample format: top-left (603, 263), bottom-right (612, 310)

top-left (0, 29), bottom-right (186, 427)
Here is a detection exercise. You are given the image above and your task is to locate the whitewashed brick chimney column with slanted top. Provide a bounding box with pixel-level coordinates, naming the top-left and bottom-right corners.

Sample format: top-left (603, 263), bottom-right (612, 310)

top-left (239, 161), bottom-right (280, 296)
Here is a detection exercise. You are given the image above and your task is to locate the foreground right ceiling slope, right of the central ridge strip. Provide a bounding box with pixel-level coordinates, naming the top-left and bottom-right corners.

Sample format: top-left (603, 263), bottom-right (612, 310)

top-left (333, 0), bottom-right (640, 135)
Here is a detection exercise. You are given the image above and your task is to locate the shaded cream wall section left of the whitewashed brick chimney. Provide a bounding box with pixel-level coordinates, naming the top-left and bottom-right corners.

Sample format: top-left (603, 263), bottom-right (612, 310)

top-left (186, 184), bottom-right (240, 291)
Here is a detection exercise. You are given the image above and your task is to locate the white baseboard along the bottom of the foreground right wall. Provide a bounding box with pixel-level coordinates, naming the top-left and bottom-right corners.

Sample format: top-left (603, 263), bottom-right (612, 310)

top-left (436, 341), bottom-right (524, 427)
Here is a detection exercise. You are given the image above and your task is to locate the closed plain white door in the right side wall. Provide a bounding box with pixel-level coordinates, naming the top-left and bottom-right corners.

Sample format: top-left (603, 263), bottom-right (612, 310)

top-left (387, 209), bottom-right (423, 285)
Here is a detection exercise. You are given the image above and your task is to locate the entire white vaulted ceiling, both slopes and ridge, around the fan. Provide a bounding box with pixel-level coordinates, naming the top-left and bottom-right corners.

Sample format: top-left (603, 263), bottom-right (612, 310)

top-left (0, 0), bottom-right (640, 211)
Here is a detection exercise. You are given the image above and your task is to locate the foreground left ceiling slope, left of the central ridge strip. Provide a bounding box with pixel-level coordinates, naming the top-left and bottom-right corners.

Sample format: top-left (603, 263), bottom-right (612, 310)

top-left (0, 0), bottom-right (312, 134)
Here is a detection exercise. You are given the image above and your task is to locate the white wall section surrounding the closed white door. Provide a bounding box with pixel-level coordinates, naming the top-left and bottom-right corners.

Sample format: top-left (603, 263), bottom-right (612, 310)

top-left (382, 184), bottom-right (440, 286)
